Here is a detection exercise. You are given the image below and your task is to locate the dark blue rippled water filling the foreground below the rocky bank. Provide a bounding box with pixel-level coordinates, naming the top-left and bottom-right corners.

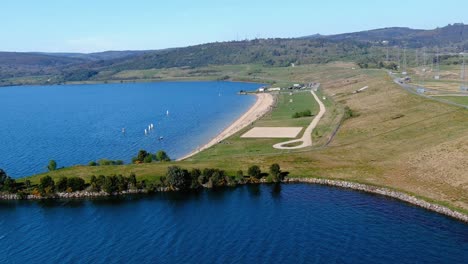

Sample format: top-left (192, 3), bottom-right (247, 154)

top-left (0, 184), bottom-right (468, 263)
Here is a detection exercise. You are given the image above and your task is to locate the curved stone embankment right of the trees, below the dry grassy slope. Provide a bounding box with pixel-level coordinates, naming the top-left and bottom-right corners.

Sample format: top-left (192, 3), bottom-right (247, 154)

top-left (284, 178), bottom-right (468, 223)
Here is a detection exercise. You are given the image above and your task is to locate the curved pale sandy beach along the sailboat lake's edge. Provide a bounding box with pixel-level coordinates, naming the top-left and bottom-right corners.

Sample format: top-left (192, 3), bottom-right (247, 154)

top-left (178, 93), bottom-right (274, 161)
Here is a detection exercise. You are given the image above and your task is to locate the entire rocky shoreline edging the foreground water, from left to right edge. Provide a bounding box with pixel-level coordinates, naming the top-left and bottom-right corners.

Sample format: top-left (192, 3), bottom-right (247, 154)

top-left (0, 178), bottom-right (468, 223)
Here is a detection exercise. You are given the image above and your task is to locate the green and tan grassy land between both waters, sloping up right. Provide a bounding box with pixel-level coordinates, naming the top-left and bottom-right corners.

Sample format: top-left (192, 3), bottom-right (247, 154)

top-left (20, 63), bottom-right (468, 213)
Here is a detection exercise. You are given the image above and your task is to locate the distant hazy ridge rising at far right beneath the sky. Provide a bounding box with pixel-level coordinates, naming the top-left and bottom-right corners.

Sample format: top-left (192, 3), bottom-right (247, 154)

top-left (303, 23), bottom-right (468, 48)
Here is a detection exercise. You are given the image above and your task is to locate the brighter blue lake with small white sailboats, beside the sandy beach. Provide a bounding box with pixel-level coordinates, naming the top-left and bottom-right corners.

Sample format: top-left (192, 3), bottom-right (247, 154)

top-left (0, 82), bottom-right (260, 177)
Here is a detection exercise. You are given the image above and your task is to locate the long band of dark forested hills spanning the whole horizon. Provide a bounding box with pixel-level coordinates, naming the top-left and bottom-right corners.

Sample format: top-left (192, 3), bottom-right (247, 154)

top-left (0, 24), bottom-right (468, 85)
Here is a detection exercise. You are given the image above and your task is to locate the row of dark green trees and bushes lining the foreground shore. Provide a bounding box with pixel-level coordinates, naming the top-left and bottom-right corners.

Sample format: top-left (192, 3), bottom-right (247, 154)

top-left (0, 163), bottom-right (286, 197)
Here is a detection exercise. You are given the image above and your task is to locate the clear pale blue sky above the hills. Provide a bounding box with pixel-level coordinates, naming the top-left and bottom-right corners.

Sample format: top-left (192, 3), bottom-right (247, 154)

top-left (0, 0), bottom-right (468, 53)
